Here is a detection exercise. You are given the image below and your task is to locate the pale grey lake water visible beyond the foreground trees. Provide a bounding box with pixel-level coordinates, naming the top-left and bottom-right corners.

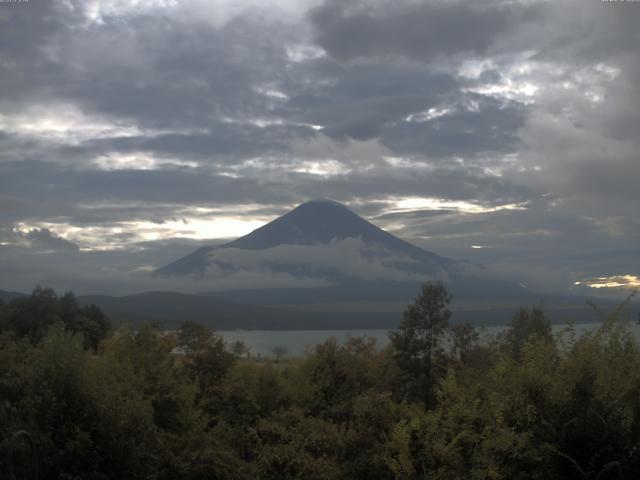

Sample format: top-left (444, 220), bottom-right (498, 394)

top-left (217, 323), bottom-right (640, 357)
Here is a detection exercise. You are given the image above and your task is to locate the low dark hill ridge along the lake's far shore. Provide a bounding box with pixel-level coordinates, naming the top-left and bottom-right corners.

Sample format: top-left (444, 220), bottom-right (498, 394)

top-left (0, 284), bottom-right (638, 330)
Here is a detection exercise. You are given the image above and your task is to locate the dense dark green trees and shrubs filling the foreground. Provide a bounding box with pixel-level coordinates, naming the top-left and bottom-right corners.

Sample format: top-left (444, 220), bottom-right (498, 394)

top-left (0, 283), bottom-right (640, 480)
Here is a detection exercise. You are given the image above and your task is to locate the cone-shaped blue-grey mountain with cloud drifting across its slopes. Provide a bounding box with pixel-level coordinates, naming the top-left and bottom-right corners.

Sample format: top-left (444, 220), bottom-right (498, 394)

top-left (155, 200), bottom-right (532, 312)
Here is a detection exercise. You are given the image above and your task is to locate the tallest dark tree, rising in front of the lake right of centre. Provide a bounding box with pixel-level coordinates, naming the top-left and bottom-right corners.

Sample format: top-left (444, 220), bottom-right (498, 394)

top-left (389, 282), bottom-right (451, 406)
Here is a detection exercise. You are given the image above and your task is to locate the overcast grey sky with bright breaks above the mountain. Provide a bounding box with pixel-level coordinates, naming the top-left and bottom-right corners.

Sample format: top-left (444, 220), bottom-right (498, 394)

top-left (0, 0), bottom-right (640, 293)
